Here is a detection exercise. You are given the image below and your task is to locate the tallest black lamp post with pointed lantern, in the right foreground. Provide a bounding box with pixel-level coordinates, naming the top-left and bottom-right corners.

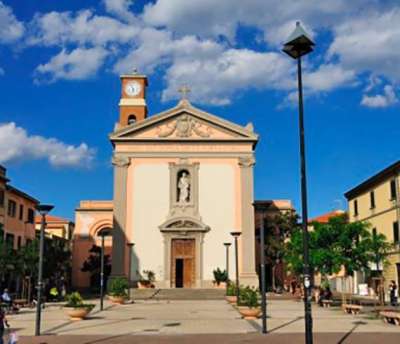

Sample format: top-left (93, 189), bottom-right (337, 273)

top-left (283, 22), bottom-right (315, 344)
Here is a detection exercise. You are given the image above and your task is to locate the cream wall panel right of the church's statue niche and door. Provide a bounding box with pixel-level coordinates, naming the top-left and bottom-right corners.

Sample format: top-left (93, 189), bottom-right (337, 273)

top-left (199, 163), bottom-right (237, 280)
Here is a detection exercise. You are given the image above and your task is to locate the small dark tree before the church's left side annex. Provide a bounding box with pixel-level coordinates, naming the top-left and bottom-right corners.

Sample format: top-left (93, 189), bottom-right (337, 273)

top-left (81, 245), bottom-right (111, 289)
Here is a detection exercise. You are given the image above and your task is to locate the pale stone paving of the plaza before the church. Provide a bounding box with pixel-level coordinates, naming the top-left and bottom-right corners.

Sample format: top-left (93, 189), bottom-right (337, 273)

top-left (5, 300), bottom-right (400, 344)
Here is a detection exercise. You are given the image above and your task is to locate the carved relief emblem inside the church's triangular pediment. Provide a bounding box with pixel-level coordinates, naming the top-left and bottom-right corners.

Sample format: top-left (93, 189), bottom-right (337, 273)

top-left (157, 115), bottom-right (211, 137)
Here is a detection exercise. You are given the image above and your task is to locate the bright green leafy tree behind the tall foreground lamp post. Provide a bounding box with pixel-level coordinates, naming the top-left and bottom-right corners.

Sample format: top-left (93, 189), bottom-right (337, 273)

top-left (285, 215), bottom-right (392, 286)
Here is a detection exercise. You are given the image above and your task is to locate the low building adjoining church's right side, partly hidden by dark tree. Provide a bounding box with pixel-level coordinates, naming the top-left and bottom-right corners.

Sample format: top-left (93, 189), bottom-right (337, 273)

top-left (254, 200), bottom-right (295, 290)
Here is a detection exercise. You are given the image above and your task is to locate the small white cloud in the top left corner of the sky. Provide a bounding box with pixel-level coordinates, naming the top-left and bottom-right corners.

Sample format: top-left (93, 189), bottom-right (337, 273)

top-left (0, 1), bottom-right (25, 43)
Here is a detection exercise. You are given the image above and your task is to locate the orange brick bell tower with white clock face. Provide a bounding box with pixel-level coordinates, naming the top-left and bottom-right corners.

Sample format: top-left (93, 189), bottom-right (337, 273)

top-left (118, 71), bottom-right (147, 128)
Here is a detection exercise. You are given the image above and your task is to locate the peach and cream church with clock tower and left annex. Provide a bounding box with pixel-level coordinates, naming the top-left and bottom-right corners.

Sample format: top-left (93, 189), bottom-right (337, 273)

top-left (73, 74), bottom-right (258, 288)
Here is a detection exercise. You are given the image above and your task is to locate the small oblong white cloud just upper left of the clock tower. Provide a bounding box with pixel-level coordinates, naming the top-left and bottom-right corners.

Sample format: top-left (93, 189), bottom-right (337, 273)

top-left (35, 47), bottom-right (108, 83)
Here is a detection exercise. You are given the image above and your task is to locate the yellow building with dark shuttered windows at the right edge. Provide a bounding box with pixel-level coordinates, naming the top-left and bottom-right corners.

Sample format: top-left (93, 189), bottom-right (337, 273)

top-left (345, 161), bottom-right (400, 292)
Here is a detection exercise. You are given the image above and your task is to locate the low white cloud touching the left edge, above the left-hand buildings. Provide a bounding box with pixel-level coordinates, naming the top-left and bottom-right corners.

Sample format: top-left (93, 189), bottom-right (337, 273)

top-left (0, 122), bottom-right (95, 168)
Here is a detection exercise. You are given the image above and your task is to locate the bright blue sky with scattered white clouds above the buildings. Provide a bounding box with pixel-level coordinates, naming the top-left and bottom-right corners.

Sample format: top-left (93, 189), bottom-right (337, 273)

top-left (0, 0), bottom-right (400, 218)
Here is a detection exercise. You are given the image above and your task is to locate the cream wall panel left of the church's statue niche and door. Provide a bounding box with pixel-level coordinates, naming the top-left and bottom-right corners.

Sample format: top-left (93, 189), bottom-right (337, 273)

top-left (128, 163), bottom-right (169, 280)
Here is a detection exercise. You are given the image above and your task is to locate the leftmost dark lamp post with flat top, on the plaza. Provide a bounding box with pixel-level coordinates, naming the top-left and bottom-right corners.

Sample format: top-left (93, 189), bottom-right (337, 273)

top-left (35, 204), bottom-right (54, 336)
